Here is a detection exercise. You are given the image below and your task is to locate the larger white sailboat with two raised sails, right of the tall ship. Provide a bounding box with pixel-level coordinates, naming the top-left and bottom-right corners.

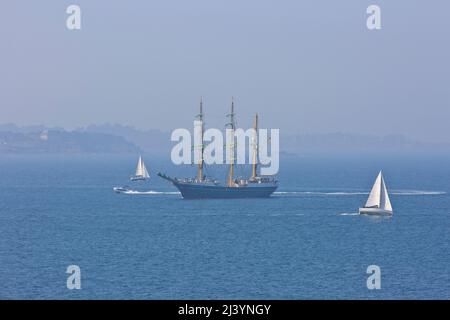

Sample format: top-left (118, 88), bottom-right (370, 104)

top-left (359, 171), bottom-right (393, 215)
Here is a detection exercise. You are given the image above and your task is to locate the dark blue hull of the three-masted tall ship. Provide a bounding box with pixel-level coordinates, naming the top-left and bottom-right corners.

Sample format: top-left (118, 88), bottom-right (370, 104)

top-left (173, 182), bottom-right (278, 199)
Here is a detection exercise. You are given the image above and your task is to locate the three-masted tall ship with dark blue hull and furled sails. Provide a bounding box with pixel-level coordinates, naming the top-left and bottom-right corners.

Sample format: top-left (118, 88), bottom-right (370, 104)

top-left (158, 101), bottom-right (278, 199)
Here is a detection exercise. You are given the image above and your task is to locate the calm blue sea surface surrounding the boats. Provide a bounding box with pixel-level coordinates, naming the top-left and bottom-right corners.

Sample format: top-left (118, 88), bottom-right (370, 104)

top-left (0, 155), bottom-right (450, 299)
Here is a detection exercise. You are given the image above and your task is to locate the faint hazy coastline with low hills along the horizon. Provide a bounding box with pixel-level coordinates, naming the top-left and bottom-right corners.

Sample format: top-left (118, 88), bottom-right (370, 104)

top-left (0, 124), bottom-right (450, 156)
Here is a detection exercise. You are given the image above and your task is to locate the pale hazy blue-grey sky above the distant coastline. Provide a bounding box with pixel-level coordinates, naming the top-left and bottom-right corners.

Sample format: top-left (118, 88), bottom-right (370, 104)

top-left (0, 0), bottom-right (450, 142)
